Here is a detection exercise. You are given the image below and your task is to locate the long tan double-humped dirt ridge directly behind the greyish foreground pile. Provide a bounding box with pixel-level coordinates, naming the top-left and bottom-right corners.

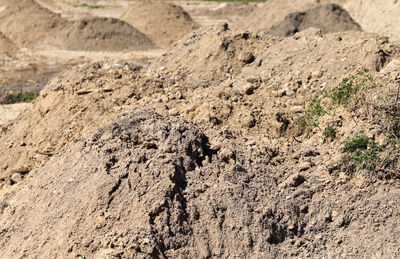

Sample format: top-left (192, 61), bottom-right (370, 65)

top-left (0, 25), bottom-right (398, 183)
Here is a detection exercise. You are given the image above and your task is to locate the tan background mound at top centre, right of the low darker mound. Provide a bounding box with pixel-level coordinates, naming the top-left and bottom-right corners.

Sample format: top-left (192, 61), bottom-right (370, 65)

top-left (121, 1), bottom-right (199, 47)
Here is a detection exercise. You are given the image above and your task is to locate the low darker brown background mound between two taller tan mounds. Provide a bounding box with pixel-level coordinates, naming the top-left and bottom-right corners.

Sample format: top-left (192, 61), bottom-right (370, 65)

top-left (45, 17), bottom-right (154, 51)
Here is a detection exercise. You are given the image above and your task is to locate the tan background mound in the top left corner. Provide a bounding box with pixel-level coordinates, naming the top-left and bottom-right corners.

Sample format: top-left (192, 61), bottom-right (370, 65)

top-left (0, 0), bottom-right (65, 47)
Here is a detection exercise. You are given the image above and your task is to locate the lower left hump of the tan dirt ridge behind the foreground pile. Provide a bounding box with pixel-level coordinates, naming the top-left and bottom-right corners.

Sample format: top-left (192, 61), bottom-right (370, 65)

top-left (0, 61), bottom-right (162, 183)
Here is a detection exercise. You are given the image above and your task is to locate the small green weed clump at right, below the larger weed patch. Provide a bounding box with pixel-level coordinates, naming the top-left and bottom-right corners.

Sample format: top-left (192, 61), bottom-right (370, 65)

top-left (343, 134), bottom-right (382, 170)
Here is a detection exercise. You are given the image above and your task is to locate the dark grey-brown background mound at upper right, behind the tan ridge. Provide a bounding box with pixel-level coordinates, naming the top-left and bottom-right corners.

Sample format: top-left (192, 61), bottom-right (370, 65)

top-left (269, 4), bottom-right (361, 37)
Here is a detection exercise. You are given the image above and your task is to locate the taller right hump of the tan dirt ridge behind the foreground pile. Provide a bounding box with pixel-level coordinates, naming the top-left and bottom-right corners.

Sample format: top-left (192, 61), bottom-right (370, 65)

top-left (148, 23), bottom-right (398, 139)
